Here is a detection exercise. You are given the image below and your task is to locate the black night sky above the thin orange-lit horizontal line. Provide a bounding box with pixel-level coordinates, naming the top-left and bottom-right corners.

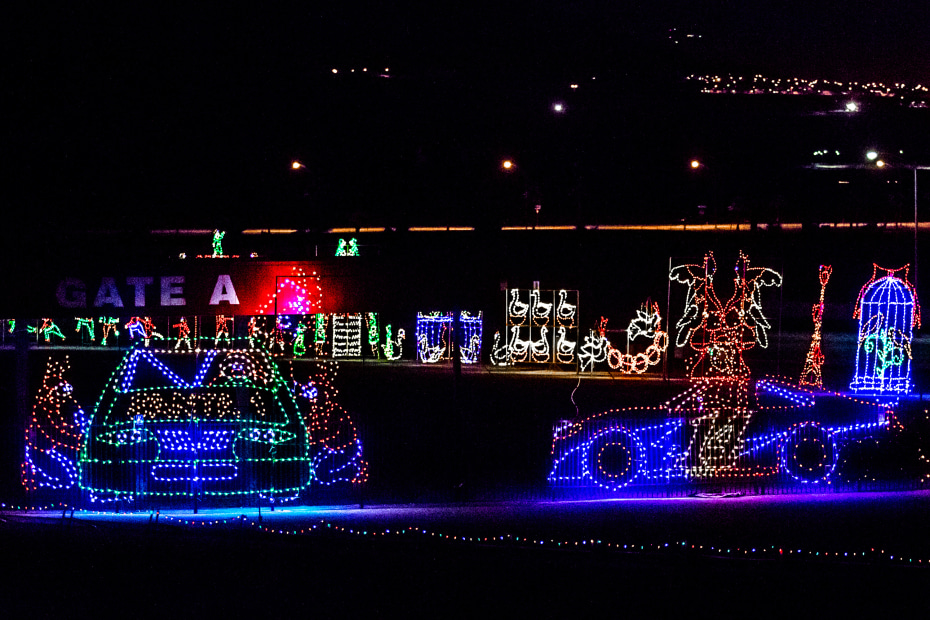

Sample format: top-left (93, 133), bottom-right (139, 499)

top-left (2, 0), bottom-right (930, 231)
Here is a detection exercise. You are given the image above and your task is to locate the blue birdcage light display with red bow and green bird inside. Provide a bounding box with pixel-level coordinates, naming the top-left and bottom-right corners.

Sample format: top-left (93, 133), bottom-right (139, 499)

top-left (849, 263), bottom-right (920, 394)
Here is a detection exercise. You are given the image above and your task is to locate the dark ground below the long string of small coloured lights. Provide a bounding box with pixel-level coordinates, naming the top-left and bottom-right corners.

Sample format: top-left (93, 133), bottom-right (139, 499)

top-left (0, 506), bottom-right (930, 618)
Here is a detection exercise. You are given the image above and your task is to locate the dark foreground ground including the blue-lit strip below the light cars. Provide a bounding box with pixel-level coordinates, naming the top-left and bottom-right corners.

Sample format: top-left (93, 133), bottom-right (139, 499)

top-left (0, 492), bottom-right (930, 617)
